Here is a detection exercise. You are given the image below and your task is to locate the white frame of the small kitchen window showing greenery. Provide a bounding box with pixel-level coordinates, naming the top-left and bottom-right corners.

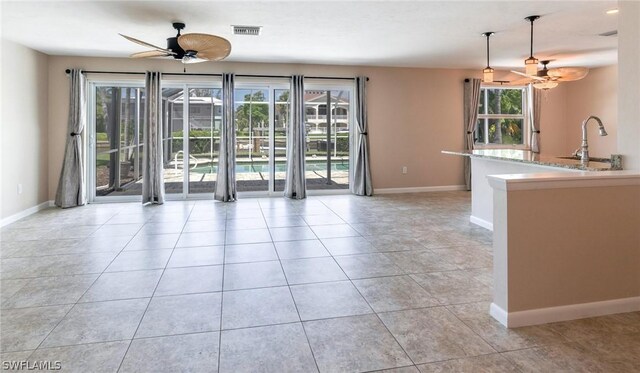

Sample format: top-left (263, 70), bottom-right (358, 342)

top-left (473, 84), bottom-right (531, 150)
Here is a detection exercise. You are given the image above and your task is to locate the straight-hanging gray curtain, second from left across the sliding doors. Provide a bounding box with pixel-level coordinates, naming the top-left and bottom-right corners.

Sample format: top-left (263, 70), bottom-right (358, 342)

top-left (142, 71), bottom-right (164, 204)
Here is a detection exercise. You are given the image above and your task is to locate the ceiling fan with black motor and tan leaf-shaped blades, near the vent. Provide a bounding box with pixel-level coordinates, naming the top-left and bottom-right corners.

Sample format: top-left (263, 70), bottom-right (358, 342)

top-left (118, 22), bottom-right (231, 63)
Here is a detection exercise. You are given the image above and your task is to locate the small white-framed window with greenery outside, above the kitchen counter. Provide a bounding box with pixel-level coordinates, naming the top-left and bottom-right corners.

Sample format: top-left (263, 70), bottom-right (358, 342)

top-left (475, 87), bottom-right (528, 147)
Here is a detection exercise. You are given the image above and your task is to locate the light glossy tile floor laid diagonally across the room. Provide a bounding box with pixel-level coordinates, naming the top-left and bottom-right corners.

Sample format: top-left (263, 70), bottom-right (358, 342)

top-left (0, 192), bottom-right (640, 372)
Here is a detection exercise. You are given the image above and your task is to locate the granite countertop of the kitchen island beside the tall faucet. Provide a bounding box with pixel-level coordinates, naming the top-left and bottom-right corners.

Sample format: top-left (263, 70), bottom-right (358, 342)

top-left (442, 149), bottom-right (622, 171)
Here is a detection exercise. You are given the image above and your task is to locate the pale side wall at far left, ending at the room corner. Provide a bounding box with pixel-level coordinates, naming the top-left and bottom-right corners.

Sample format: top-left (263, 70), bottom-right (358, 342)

top-left (0, 39), bottom-right (49, 219)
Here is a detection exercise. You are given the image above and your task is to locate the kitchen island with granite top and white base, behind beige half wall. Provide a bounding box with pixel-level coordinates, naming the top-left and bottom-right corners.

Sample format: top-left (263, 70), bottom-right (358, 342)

top-left (442, 149), bottom-right (622, 230)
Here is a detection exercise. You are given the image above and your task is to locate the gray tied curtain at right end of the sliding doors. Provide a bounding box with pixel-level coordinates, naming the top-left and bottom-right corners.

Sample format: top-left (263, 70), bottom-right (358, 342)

top-left (351, 76), bottom-right (373, 196)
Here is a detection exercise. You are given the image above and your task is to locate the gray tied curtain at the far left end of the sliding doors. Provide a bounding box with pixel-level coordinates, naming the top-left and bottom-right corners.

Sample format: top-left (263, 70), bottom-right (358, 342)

top-left (55, 69), bottom-right (87, 208)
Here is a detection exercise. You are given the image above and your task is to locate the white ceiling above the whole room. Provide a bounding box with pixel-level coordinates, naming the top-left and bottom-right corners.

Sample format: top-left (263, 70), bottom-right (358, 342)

top-left (2, 0), bottom-right (617, 68)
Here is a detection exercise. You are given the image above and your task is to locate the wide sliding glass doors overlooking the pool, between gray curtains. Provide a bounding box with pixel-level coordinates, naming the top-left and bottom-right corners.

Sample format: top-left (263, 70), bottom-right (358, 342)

top-left (88, 79), bottom-right (353, 201)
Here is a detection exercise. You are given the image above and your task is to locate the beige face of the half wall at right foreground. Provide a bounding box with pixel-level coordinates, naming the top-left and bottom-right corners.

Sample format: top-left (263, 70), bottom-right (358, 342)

top-left (507, 185), bottom-right (640, 312)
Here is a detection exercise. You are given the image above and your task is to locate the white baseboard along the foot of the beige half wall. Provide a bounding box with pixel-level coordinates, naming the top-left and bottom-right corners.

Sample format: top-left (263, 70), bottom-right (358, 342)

top-left (489, 297), bottom-right (640, 328)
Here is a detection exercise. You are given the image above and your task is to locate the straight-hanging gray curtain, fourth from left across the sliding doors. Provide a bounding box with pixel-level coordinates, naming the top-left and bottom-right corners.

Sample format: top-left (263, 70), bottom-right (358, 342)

top-left (284, 75), bottom-right (307, 199)
